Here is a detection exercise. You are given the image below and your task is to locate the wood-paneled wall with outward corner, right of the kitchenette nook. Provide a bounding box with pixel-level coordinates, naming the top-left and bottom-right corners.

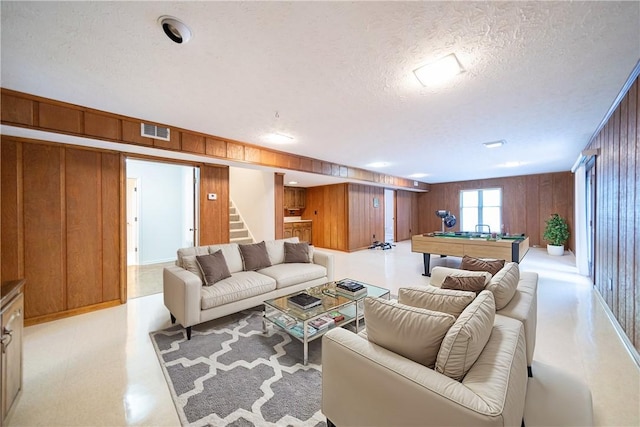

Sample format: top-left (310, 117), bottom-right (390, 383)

top-left (302, 183), bottom-right (384, 251)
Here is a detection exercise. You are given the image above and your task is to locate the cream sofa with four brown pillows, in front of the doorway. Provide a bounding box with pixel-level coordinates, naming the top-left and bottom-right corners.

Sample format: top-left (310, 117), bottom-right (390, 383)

top-left (163, 237), bottom-right (334, 339)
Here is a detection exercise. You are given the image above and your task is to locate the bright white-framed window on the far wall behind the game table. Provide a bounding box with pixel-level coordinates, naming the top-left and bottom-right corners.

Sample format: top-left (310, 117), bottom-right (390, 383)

top-left (460, 188), bottom-right (502, 233)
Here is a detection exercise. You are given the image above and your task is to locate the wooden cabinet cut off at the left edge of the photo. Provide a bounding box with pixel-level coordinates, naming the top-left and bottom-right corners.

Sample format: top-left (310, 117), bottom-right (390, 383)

top-left (0, 280), bottom-right (24, 426)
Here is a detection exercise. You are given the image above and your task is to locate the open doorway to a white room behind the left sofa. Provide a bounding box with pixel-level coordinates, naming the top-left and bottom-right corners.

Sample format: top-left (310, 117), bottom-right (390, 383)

top-left (126, 158), bottom-right (200, 298)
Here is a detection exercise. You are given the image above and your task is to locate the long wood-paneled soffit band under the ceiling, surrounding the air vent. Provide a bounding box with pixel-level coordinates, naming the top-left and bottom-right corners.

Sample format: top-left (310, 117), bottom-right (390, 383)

top-left (0, 88), bottom-right (429, 190)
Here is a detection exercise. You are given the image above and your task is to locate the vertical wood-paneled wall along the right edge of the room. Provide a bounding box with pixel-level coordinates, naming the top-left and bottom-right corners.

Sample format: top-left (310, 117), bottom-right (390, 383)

top-left (587, 78), bottom-right (640, 351)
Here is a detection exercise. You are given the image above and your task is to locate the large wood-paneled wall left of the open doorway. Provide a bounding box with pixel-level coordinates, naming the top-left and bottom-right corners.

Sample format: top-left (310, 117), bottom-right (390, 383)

top-left (0, 136), bottom-right (126, 323)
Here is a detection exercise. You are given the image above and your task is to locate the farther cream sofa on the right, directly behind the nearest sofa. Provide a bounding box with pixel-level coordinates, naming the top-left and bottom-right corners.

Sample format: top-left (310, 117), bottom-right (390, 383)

top-left (430, 263), bottom-right (538, 377)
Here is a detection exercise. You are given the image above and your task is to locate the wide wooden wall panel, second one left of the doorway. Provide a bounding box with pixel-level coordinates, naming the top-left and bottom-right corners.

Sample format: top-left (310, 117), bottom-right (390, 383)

top-left (64, 148), bottom-right (102, 309)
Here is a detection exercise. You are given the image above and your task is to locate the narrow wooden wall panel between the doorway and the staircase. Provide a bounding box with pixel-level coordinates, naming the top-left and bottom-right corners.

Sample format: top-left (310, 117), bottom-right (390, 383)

top-left (200, 165), bottom-right (229, 245)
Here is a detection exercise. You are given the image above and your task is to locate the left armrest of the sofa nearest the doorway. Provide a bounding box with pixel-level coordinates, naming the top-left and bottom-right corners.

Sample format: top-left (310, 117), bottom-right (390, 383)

top-left (162, 266), bottom-right (202, 328)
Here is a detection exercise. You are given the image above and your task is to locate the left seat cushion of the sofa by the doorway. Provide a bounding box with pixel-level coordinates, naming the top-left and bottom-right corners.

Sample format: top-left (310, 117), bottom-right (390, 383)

top-left (200, 271), bottom-right (276, 310)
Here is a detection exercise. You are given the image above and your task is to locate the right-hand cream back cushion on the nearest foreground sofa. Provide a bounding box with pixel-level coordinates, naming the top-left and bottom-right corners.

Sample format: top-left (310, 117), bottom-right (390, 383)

top-left (435, 290), bottom-right (496, 381)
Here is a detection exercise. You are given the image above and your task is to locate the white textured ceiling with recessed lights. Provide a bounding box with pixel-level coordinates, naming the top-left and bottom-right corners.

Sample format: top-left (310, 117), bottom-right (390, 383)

top-left (1, 1), bottom-right (640, 185)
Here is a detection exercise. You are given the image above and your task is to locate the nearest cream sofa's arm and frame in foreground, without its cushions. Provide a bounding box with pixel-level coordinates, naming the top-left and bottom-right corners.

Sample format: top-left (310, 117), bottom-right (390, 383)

top-left (322, 319), bottom-right (526, 427)
